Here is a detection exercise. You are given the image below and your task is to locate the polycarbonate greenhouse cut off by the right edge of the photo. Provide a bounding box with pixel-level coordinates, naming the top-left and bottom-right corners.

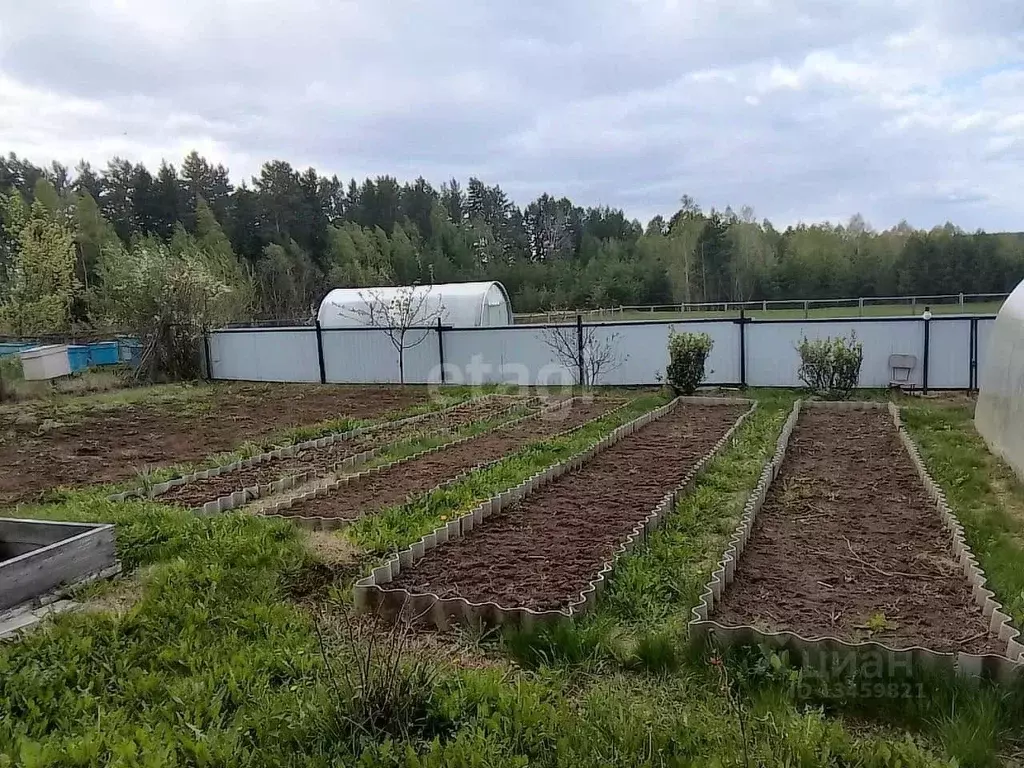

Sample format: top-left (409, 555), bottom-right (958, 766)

top-left (974, 282), bottom-right (1024, 479)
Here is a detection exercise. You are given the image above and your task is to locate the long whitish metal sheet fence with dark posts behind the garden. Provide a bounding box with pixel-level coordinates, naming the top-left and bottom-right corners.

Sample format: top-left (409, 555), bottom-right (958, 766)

top-left (205, 315), bottom-right (995, 391)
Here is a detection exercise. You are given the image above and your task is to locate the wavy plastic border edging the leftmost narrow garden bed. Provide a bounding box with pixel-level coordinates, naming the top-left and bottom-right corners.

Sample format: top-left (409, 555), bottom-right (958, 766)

top-left (108, 394), bottom-right (539, 512)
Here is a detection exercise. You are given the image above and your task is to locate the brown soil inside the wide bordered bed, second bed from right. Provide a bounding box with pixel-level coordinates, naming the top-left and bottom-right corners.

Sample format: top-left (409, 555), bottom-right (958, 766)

top-left (389, 403), bottom-right (746, 610)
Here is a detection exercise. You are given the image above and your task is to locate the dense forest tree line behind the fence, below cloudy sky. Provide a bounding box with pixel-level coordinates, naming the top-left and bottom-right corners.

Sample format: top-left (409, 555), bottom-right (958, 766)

top-left (0, 152), bottom-right (1024, 334)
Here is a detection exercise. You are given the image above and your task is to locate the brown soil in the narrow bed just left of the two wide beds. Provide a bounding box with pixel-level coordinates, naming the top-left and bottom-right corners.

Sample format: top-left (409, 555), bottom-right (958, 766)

top-left (281, 398), bottom-right (623, 520)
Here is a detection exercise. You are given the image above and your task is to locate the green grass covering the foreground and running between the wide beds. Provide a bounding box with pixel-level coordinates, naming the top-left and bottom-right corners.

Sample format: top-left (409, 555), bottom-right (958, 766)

top-left (0, 391), bottom-right (1024, 768)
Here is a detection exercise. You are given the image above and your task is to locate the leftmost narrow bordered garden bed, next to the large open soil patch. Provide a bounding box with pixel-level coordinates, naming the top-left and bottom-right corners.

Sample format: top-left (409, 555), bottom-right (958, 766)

top-left (153, 395), bottom-right (531, 508)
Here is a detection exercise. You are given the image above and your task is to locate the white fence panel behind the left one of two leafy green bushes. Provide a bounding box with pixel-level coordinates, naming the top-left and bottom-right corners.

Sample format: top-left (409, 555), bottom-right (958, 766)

top-left (594, 321), bottom-right (739, 386)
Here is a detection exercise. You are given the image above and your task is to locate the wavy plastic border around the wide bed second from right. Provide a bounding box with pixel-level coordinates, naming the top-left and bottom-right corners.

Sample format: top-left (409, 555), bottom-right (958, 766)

top-left (353, 396), bottom-right (758, 629)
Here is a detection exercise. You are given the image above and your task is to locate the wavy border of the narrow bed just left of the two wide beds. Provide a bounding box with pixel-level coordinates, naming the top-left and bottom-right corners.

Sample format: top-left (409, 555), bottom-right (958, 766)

top-left (260, 397), bottom-right (632, 530)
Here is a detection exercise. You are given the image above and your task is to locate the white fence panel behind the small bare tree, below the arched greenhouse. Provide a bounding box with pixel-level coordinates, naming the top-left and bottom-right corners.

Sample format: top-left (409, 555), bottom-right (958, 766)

top-left (323, 329), bottom-right (440, 384)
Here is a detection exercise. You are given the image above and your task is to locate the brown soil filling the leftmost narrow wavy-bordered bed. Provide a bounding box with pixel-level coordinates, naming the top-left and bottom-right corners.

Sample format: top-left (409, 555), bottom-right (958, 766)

top-left (160, 395), bottom-right (525, 508)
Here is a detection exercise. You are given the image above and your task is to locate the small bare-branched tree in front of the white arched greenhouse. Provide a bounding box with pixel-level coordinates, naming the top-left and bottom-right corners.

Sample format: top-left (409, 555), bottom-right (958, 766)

top-left (342, 286), bottom-right (444, 384)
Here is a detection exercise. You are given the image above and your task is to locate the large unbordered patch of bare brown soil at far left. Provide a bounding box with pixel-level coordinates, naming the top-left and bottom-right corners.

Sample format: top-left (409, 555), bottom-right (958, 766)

top-left (0, 384), bottom-right (430, 506)
